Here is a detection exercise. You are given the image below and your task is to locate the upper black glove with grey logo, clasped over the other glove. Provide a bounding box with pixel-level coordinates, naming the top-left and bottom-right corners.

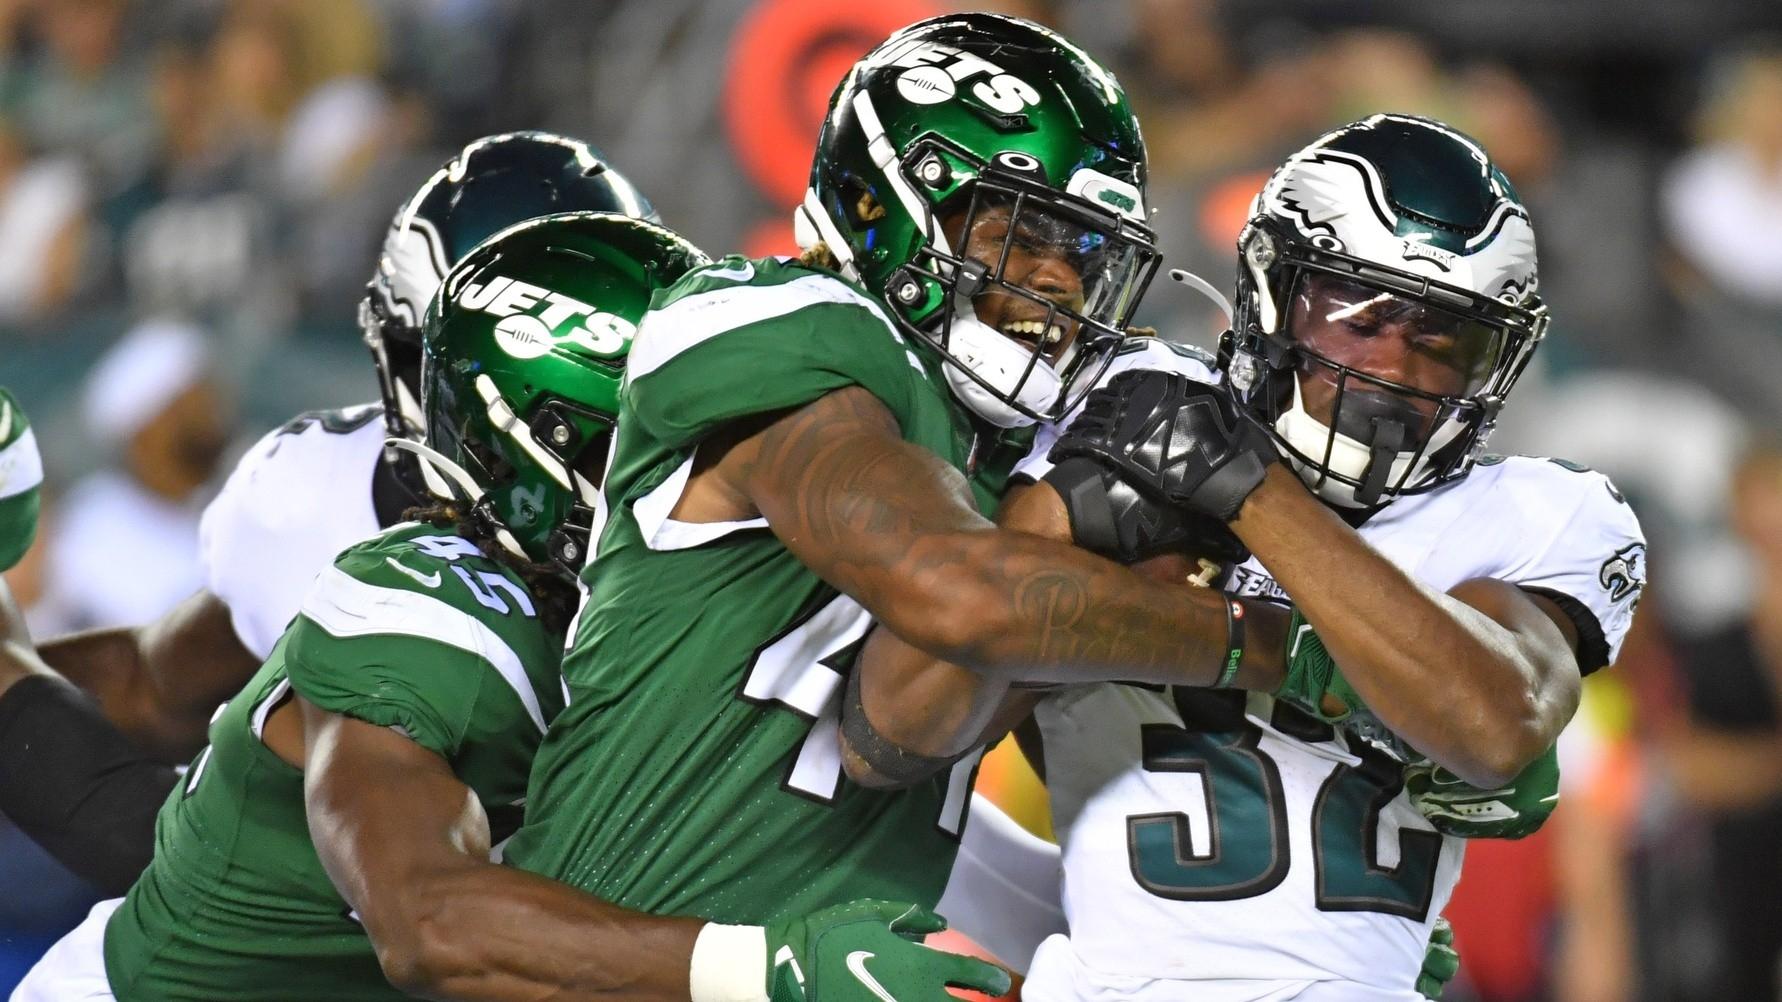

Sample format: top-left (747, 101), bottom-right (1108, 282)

top-left (1050, 369), bottom-right (1279, 522)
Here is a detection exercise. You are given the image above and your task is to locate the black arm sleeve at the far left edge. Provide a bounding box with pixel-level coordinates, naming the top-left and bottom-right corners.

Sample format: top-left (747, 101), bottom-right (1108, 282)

top-left (0, 676), bottom-right (180, 895)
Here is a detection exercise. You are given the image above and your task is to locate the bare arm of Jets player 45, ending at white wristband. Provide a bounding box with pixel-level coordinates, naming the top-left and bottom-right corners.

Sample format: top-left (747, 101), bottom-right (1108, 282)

top-left (299, 699), bottom-right (702, 1002)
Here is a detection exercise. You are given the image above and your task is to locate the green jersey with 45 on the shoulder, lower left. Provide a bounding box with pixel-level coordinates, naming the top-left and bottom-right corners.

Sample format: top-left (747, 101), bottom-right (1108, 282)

top-left (105, 524), bottom-right (561, 1002)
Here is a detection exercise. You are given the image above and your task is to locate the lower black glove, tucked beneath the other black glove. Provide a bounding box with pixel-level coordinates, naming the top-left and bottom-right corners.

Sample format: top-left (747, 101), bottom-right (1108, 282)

top-left (1044, 456), bottom-right (1249, 563)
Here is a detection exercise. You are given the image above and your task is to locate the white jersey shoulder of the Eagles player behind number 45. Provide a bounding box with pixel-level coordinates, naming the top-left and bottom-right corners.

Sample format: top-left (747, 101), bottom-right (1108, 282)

top-left (198, 403), bottom-right (394, 660)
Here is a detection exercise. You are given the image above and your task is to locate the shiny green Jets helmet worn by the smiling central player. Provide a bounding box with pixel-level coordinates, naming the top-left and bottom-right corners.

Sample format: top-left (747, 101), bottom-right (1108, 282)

top-left (795, 14), bottom-right (1158, 428)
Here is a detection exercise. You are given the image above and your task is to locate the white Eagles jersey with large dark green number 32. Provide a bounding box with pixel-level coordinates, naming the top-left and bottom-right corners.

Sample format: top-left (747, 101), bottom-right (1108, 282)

top-left (1021, 338), bottom-right (1645, 1002)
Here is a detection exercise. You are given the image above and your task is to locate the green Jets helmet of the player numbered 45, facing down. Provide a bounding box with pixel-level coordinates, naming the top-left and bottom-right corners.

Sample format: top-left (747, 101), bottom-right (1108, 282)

top-left (388, 212), bottom-right (709, 576)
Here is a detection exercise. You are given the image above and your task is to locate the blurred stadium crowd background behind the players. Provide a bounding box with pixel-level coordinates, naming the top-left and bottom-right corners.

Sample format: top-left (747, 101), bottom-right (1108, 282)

top-left (0, 0), bottom-right (1782, 1002)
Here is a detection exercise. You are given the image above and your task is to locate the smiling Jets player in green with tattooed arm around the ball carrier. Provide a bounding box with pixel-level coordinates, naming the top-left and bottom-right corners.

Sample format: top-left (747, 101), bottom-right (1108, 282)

top-left (491, 14), bottom-right (1375, 1000)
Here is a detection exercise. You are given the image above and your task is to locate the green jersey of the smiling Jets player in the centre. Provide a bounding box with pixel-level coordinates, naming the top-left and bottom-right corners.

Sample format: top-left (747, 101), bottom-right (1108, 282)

top-left (506, 257), bottom-right (1030, 922)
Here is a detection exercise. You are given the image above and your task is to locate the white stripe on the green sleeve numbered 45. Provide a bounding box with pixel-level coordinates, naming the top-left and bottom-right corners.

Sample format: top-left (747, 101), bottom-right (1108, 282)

top-left (301, 567), bottom-right (545, 733)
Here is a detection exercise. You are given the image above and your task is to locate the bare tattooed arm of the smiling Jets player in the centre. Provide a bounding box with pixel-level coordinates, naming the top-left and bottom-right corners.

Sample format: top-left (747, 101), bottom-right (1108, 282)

top-left (675, 387), bottom-right (1285, 685)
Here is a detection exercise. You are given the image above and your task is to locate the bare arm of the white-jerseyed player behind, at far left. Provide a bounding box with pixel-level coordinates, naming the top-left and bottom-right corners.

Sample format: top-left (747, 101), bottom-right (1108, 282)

top-left (37, 592), bottom-right (260, 763)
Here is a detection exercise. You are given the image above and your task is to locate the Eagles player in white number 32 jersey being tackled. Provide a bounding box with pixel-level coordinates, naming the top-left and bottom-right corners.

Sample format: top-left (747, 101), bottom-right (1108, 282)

top-left (845, 114), bottom-right (1645, 1000)
